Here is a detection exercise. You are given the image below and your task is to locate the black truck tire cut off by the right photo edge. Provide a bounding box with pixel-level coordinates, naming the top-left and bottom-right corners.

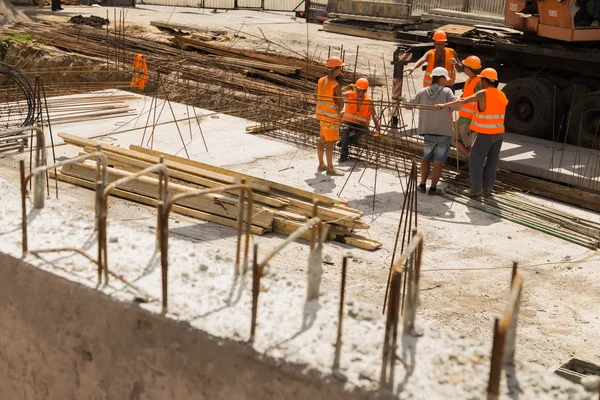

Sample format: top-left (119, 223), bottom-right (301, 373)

top-left (569, 92), bottom-right (600, 148)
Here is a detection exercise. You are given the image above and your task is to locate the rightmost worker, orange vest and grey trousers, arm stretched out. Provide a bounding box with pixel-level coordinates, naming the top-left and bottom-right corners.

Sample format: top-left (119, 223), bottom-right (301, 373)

top-left (436, 68), bottom-right (508, 197)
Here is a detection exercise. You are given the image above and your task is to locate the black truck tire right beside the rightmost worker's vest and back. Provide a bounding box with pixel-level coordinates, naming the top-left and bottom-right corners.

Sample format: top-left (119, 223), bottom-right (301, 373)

top-left (502, 78), bottom-right (554, 138)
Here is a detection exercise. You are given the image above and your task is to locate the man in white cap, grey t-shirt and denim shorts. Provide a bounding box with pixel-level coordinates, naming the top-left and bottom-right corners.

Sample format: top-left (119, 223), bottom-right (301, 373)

top-left (403, 67), bottom-right (456, 195)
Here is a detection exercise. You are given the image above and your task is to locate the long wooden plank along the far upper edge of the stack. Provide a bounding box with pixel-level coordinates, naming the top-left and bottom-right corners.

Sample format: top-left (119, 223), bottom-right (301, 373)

top-left (131, 145), bottom-right (346, 205)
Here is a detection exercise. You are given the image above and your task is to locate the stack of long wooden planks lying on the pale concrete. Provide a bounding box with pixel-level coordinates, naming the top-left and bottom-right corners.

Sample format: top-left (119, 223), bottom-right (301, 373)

top-left (52, 133), bottom-right (381, 250)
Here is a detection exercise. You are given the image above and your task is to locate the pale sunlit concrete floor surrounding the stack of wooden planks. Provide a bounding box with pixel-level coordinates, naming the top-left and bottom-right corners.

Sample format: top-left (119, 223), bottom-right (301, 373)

top-left (0, 87), bottom-right (600, 367)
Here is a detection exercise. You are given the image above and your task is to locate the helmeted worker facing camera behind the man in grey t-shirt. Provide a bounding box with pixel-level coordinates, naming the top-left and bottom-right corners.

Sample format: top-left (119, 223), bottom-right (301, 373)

top-left (406, 30), bottom-right (460, 91)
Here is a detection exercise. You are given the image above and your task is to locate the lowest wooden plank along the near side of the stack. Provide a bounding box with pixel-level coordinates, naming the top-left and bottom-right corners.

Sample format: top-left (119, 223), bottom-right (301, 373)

top-left (49, 171), bottom-right (265, 235)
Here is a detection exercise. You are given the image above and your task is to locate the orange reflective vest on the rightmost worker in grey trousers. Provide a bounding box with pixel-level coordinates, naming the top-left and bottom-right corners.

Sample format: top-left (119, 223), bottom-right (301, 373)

top-left (470, 88), bottom-right (508, 135)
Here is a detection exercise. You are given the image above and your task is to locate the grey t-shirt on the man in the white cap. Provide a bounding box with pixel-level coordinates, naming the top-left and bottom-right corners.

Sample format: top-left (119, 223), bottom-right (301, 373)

top-left (409, 84), bottom-right (456, 137)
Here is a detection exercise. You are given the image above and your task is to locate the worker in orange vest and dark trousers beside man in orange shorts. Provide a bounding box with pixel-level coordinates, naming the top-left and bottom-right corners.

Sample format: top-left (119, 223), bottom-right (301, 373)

top-left (338, 78), bottom-right (381, 163)
